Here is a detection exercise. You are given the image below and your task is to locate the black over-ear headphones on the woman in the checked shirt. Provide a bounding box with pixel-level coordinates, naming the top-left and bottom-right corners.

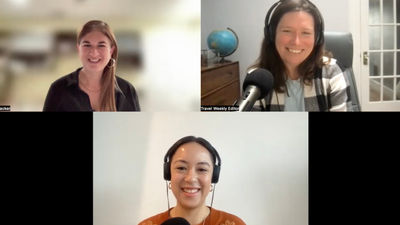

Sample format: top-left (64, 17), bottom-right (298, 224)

top-left (264, 0), bottom-right (325, 46)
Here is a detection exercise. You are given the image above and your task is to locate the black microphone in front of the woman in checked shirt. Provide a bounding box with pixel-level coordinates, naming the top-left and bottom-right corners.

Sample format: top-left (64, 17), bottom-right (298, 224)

top-left (238, 68), bottom-right (274, 111)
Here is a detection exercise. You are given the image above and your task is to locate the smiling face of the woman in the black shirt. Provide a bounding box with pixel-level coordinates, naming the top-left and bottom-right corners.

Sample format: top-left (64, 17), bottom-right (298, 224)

top-left (77, 31), bottom-right (114, 72)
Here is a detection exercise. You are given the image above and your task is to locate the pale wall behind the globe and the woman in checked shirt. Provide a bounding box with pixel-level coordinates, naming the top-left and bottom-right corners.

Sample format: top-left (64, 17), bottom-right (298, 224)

top-left (201, 0), bottom-right (351, 89)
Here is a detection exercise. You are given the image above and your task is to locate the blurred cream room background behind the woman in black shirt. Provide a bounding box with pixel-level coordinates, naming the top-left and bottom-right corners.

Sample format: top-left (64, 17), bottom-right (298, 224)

top-left (0, 0), bottom-right (201, 111)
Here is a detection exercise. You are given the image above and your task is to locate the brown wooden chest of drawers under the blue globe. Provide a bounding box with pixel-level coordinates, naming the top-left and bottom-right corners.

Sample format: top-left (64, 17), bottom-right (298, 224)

top-left (201, 62), bottom-right (240, 106)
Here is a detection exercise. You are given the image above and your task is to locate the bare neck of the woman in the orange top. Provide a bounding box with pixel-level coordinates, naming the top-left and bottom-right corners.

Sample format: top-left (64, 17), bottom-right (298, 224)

top-left (170, 205), bottom-right (210, 225)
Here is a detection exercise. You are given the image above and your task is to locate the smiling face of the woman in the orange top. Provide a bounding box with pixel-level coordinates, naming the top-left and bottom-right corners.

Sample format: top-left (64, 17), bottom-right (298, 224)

top-left (171, 142), bottom-right (213, 209)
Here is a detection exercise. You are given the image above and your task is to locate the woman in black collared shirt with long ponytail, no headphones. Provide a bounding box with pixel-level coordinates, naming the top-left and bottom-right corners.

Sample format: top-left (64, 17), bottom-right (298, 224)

top-left (43, 20), bottom-right (140, 111)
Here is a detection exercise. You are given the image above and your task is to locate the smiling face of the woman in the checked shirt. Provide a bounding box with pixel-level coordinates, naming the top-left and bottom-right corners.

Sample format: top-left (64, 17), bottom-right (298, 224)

top-left (275, 11), bottom-right (315, 70)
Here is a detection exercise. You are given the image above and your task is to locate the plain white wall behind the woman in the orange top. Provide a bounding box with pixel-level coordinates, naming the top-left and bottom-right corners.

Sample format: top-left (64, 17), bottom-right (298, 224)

top-left (93, 113), bottom-right (308, 225)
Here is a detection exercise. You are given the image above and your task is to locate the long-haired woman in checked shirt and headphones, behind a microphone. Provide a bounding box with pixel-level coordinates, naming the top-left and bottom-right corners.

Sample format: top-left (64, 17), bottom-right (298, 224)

top-left (249, 0), bottom-right (351, 111)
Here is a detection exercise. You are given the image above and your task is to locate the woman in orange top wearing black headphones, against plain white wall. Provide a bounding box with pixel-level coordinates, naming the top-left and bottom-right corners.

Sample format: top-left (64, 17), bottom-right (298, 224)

top-left (139, 136), bottom-right (245, 225)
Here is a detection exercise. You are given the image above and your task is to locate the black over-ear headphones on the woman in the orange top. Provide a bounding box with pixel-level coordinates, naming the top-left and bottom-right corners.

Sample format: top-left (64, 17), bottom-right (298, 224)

top-left (164, 136), bottom-right (221, 183)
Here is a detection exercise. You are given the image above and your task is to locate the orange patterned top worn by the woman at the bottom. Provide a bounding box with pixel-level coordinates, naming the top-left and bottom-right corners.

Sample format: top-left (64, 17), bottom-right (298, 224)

top-left (138, 208), bottom-right (246, 225)
